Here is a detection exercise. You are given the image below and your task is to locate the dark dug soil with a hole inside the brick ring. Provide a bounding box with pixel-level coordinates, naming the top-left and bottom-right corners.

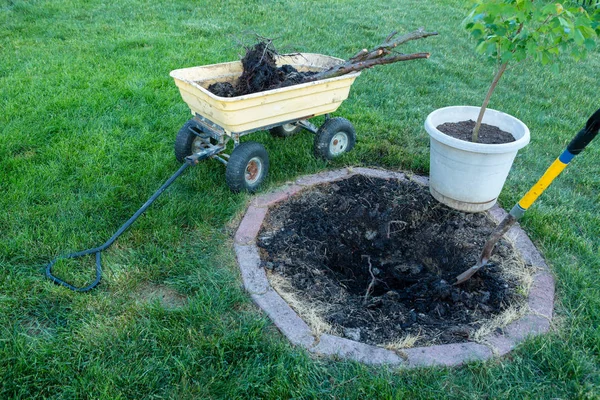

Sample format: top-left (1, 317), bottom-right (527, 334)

top-left (258, 176), bottom-right (523, 345)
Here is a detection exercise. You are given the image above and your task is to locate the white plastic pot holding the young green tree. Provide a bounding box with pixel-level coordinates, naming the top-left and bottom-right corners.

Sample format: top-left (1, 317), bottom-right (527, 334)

top-left (425, 106), bottom-right (529, 212)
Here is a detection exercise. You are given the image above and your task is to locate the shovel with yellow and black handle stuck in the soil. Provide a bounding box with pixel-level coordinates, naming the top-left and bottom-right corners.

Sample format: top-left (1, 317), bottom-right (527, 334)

top-left (454, 109), bottom-right (600, 285)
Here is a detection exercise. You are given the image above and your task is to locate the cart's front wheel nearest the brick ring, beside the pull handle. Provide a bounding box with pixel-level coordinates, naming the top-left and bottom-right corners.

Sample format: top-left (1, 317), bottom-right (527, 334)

top-left (225, 142), bottom-right (269, 193)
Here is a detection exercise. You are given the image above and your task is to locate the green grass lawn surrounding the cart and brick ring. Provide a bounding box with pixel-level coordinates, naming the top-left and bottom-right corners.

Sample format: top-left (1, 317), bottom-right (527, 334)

top-left (0, 0), bottom-right (600, 399)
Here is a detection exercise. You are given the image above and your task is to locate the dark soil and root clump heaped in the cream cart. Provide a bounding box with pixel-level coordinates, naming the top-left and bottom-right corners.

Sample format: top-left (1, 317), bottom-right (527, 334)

top-left (208, 42), bottom-right (315, 97)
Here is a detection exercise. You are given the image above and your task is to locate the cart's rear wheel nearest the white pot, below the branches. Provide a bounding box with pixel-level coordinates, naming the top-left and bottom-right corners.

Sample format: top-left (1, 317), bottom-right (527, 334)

top-left (314, 117), bottom-right (356, 160)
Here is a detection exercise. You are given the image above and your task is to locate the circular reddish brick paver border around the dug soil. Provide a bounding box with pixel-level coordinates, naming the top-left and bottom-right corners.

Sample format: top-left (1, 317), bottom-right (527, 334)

top-left (234, 168), bottom-right (554, 367)
